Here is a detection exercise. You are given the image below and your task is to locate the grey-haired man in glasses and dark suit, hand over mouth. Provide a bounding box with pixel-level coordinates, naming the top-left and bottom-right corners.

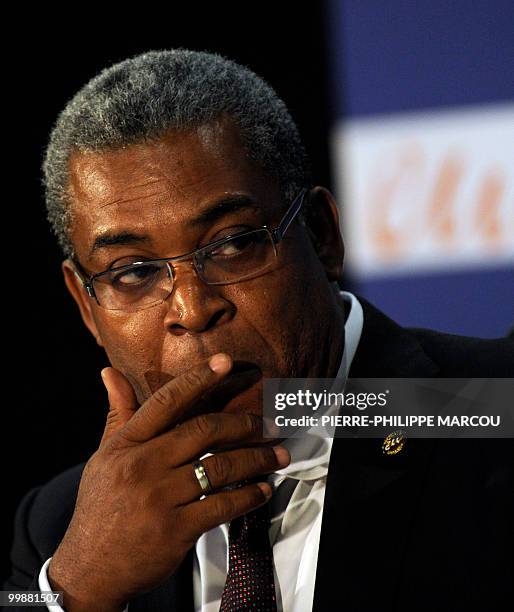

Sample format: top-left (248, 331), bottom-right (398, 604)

top-left (5, 50), bottom-right (513, 612)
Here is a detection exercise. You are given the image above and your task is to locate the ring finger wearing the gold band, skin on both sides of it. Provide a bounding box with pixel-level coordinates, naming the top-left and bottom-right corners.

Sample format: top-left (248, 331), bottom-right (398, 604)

top-left (174, 446), bottom-right (290, 504)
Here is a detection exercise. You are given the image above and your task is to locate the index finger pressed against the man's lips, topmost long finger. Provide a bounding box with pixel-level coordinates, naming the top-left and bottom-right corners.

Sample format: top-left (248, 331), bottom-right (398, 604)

top-left (120, 353), bottom-right (232, 442)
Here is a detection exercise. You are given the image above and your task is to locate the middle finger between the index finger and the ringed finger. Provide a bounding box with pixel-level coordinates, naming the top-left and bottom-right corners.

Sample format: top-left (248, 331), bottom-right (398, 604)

top-left (147, 412), bottom-right (263, 467)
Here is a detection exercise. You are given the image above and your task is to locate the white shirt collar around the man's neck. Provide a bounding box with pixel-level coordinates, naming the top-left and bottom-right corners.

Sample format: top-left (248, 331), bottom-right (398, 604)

top-left (269, 291), bottom-right (364, 488)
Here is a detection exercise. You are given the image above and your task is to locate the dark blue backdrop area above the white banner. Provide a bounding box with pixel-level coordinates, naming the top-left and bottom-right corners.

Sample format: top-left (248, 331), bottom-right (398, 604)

top-left (328, 0), bottom-right (514, 117)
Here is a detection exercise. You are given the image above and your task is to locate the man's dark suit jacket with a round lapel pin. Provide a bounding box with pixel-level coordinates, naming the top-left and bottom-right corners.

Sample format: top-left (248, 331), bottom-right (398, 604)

top-left (4, 300), bottom-right (514, 612)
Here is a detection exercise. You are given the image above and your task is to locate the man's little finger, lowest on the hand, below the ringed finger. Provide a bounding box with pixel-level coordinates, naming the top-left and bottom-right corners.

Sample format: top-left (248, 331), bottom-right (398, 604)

top-left (178, 482), bottom-right (271, 544)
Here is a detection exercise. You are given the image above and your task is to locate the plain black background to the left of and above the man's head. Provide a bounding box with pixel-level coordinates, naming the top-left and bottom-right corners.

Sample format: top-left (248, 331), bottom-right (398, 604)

top-left (1, 2), bottom-right (331, 578)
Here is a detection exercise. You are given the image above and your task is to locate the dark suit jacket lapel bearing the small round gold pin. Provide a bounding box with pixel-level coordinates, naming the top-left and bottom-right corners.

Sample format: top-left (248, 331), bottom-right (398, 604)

top-left (313, 298), bottom-right (438, 612)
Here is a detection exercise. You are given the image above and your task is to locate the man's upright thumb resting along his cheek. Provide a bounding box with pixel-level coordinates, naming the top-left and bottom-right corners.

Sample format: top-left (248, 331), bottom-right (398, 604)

top-left (100, 368), bottom-right (139, 445)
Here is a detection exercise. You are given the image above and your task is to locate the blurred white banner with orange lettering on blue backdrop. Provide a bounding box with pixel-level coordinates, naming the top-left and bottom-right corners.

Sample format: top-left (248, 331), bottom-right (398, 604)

top-left (334, 104), bottom-right (514, 277)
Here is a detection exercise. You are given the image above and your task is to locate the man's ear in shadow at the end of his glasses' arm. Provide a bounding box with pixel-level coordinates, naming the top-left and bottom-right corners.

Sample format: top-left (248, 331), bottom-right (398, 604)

top-left (304, 186), bottom-right (344, 282)
